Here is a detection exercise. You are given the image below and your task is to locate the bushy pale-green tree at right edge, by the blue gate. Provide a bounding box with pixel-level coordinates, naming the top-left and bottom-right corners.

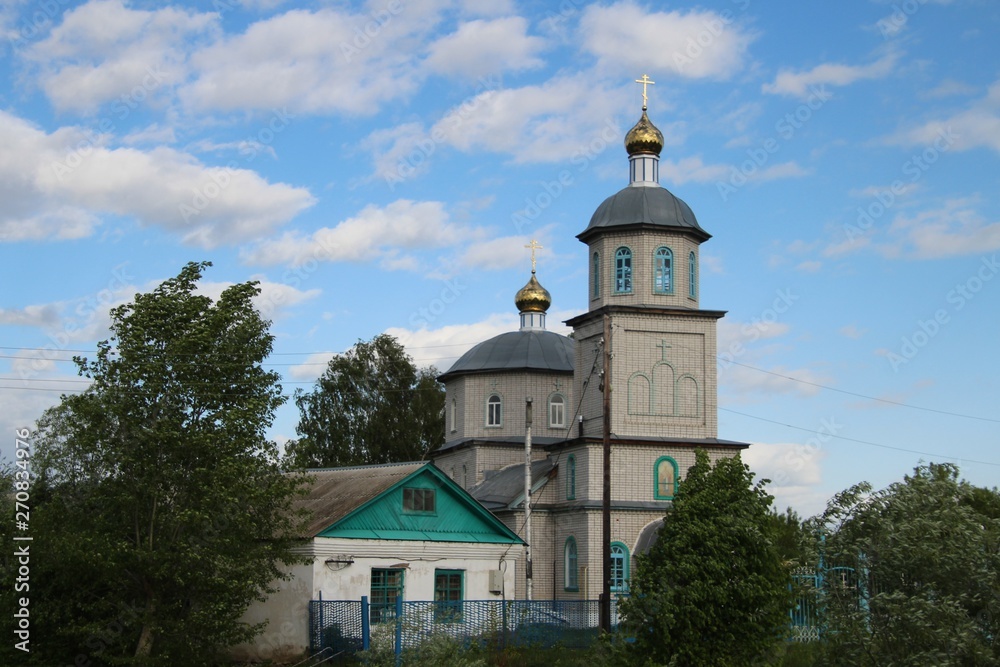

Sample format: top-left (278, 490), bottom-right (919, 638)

top-left (819, 463), bottom-right (1000, 667)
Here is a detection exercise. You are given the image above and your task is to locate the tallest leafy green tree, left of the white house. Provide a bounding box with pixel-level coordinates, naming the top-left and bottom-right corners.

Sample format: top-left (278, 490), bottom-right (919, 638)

top-left (15, 262), bottom-right (300, 665)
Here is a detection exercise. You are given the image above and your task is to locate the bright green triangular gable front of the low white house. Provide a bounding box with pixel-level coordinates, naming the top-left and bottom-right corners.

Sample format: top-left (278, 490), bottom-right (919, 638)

top-left (317, 463), bottom-right (522, 544)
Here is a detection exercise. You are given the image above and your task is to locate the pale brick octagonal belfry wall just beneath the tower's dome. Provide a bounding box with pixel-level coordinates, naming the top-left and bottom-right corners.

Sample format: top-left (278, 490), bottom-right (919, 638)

top-left (587, 231), bottom-right (699, 310)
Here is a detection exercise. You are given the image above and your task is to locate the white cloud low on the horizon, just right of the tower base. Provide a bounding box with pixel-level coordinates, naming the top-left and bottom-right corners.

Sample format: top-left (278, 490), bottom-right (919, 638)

top-left (741, 442), bottom-right (826, 518)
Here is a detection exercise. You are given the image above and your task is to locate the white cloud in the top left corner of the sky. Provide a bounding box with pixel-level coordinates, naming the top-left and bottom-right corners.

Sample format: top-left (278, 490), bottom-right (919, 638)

top-left (26, 0), bottom-right (219, 115)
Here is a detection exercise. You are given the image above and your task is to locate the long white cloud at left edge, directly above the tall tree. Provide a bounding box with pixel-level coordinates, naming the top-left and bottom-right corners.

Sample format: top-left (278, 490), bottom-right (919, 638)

top-left (0, 111), bottom-right (314, 248)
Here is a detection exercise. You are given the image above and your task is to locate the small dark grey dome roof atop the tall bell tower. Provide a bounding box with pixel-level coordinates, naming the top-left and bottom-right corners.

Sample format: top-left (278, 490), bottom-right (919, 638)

top-left (577, 185), bottom-right (712, 243)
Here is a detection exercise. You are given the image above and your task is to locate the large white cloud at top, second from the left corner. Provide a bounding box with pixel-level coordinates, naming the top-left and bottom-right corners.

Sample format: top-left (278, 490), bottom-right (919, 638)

top-left (180, 5), bottom-right (426, 115)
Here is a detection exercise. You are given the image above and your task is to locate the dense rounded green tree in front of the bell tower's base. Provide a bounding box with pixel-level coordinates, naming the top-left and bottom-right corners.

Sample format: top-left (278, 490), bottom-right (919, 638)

top-left (622, 449), bottom-right (789, 667)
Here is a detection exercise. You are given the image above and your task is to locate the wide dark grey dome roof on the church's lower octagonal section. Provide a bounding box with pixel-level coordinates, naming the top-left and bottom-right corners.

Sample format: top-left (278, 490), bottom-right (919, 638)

top-left (438, 331), bottom-right (575, 382)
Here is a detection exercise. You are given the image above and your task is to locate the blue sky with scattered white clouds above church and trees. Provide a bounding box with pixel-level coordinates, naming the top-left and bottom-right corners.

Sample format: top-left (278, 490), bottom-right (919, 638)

top-left (0, 0), bottom-right (1000, 514)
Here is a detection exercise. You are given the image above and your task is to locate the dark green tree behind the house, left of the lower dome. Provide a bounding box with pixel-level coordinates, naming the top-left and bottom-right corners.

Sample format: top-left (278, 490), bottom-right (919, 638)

top-left (286, 334), bottom-right (444, 468)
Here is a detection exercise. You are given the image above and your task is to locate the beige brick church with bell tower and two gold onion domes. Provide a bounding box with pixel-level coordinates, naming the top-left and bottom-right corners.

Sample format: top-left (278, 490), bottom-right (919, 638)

top-left (433, 90), bottom-right (749, 600)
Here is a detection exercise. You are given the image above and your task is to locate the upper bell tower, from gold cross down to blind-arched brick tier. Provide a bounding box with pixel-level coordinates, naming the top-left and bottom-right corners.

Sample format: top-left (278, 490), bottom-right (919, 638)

top-left (567, 82), bottom-right (725, 439)
